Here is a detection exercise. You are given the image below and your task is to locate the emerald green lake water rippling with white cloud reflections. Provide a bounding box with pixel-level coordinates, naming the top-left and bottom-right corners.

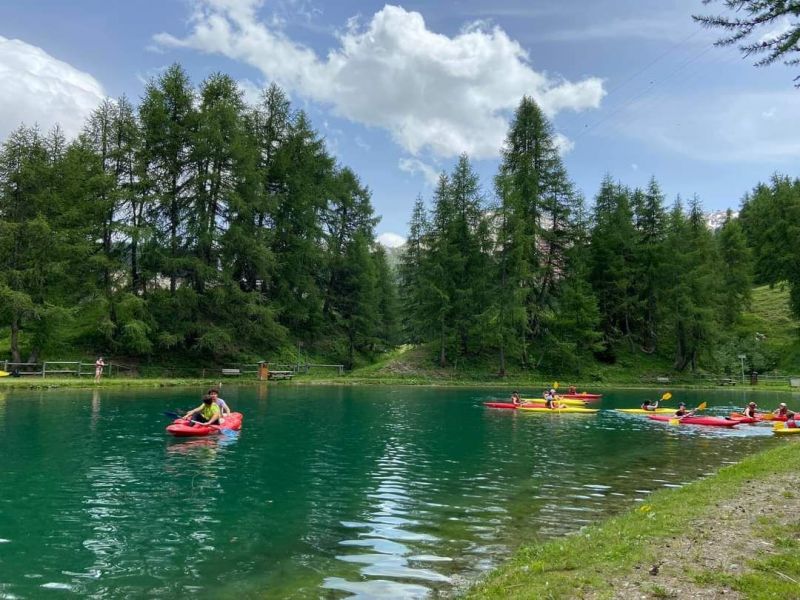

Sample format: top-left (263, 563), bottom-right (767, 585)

top-left (0, 384), bottom-right (800, 598)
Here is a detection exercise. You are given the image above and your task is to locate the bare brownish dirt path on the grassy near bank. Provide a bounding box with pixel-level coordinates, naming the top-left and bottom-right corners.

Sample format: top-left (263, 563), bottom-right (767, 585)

top-left (604, 473), bottom-right (800, 600)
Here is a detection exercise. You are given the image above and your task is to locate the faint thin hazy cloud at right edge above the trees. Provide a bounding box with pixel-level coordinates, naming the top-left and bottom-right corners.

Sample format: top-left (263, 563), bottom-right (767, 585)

top-left (619, 90), bottom-right (800, 164)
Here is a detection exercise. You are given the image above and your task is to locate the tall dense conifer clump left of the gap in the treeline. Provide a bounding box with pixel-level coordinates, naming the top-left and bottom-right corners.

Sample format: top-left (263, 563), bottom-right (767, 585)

top-left (0, 65), bottom-right (398, 364)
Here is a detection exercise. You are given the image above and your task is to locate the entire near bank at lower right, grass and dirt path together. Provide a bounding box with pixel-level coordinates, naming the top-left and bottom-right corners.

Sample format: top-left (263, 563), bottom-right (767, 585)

top-left (466, 440), bottom-right (800, 599)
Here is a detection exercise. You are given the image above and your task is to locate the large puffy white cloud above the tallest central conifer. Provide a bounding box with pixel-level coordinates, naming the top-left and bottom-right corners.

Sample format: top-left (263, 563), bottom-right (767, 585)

top-left (154, 0), bottom-right (605, 159)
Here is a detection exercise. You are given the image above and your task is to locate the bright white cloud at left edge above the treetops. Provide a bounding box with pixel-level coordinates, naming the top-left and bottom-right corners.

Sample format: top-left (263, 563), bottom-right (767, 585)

top-left (0, 36), bottom-right (105, 138)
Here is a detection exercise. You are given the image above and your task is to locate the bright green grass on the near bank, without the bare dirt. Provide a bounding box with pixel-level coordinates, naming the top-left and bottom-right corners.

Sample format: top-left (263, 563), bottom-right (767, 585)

top-left (466, 443), bottom-right (800, 599)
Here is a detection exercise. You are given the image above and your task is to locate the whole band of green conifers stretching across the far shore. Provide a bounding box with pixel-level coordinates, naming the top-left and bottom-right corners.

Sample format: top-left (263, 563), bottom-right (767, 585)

top-left (0, 65), bottom-right (800, 375)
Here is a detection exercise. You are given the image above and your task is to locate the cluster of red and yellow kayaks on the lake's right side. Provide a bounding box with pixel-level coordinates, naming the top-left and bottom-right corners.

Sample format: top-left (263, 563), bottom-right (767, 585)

top-left (483, 393), bottom-right (800, 434)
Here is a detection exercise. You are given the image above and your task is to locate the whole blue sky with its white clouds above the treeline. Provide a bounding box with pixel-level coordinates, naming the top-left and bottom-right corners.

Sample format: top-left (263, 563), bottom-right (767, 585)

top-left (0, 0), bottom-right (800, 245)
